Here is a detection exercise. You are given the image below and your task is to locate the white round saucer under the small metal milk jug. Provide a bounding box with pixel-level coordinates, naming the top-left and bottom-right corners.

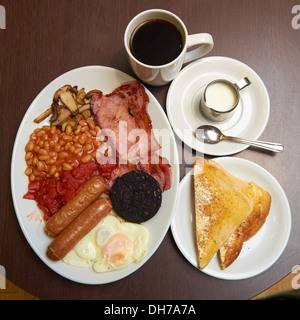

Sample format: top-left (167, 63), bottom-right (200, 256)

top-left (166, 57), bottom-right (270, 156)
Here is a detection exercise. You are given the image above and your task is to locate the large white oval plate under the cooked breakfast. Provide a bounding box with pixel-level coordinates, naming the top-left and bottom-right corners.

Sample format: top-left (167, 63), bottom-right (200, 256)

top-left (11, 66), bottom-right (179, 284)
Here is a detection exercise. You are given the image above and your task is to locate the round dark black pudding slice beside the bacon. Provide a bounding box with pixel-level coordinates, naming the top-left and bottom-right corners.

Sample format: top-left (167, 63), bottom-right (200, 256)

top-left (111, 170), bottom-right (162, 223)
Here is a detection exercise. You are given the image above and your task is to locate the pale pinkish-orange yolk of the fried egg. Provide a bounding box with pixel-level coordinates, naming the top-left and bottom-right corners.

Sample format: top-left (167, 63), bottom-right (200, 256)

top-left (102, 233), bottom-right (134, 268)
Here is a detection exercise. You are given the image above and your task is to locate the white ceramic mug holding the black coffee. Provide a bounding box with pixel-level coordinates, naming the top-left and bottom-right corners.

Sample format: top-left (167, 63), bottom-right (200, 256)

top-left (124, 9), bottom-right (214, 86)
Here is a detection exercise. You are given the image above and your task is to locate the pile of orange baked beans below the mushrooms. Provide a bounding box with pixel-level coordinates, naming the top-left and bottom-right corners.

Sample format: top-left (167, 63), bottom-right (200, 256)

top-left (25, 119), bottom-right (101, 181)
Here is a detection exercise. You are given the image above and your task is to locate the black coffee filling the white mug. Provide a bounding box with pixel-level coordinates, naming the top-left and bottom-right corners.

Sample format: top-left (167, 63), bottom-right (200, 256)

top-left (130, 19), bottom-right (183, 66)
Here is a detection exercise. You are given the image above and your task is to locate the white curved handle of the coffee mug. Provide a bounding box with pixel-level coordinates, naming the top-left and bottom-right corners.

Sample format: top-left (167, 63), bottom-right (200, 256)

top-left (183, 33), bottom-right (214, 63)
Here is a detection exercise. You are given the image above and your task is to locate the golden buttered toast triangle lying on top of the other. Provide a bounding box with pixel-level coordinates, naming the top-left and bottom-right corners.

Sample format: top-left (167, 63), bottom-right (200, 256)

top-left (194, 158), bottom-right (252, 269)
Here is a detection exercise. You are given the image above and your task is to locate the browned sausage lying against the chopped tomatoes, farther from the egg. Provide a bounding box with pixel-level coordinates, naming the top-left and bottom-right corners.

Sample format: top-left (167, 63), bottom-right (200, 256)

top-left (45, 176), bottom-right (106, 237)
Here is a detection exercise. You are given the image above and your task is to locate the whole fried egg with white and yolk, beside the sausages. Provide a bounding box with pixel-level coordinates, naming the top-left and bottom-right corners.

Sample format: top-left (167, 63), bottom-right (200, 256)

top-left (63, 215), bottom-right (149, 273)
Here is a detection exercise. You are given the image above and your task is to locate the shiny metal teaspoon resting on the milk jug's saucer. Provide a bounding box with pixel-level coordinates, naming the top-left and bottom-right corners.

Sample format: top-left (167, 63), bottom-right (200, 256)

top-left (195, 125), bottom-right (284, 152)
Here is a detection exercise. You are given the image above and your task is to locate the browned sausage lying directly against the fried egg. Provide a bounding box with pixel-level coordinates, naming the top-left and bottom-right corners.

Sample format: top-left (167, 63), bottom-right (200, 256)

top-left (46, 197), bottom-right (112, 261)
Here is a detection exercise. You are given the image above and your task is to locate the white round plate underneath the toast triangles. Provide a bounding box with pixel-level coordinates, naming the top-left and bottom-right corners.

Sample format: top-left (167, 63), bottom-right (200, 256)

top-left (171, 157), bottom-right (291, 280)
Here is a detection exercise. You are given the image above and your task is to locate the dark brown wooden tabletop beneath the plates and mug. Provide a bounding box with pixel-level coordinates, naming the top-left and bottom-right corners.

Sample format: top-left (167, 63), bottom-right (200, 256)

top-left (0, 0), bottom-right (300, 300)
